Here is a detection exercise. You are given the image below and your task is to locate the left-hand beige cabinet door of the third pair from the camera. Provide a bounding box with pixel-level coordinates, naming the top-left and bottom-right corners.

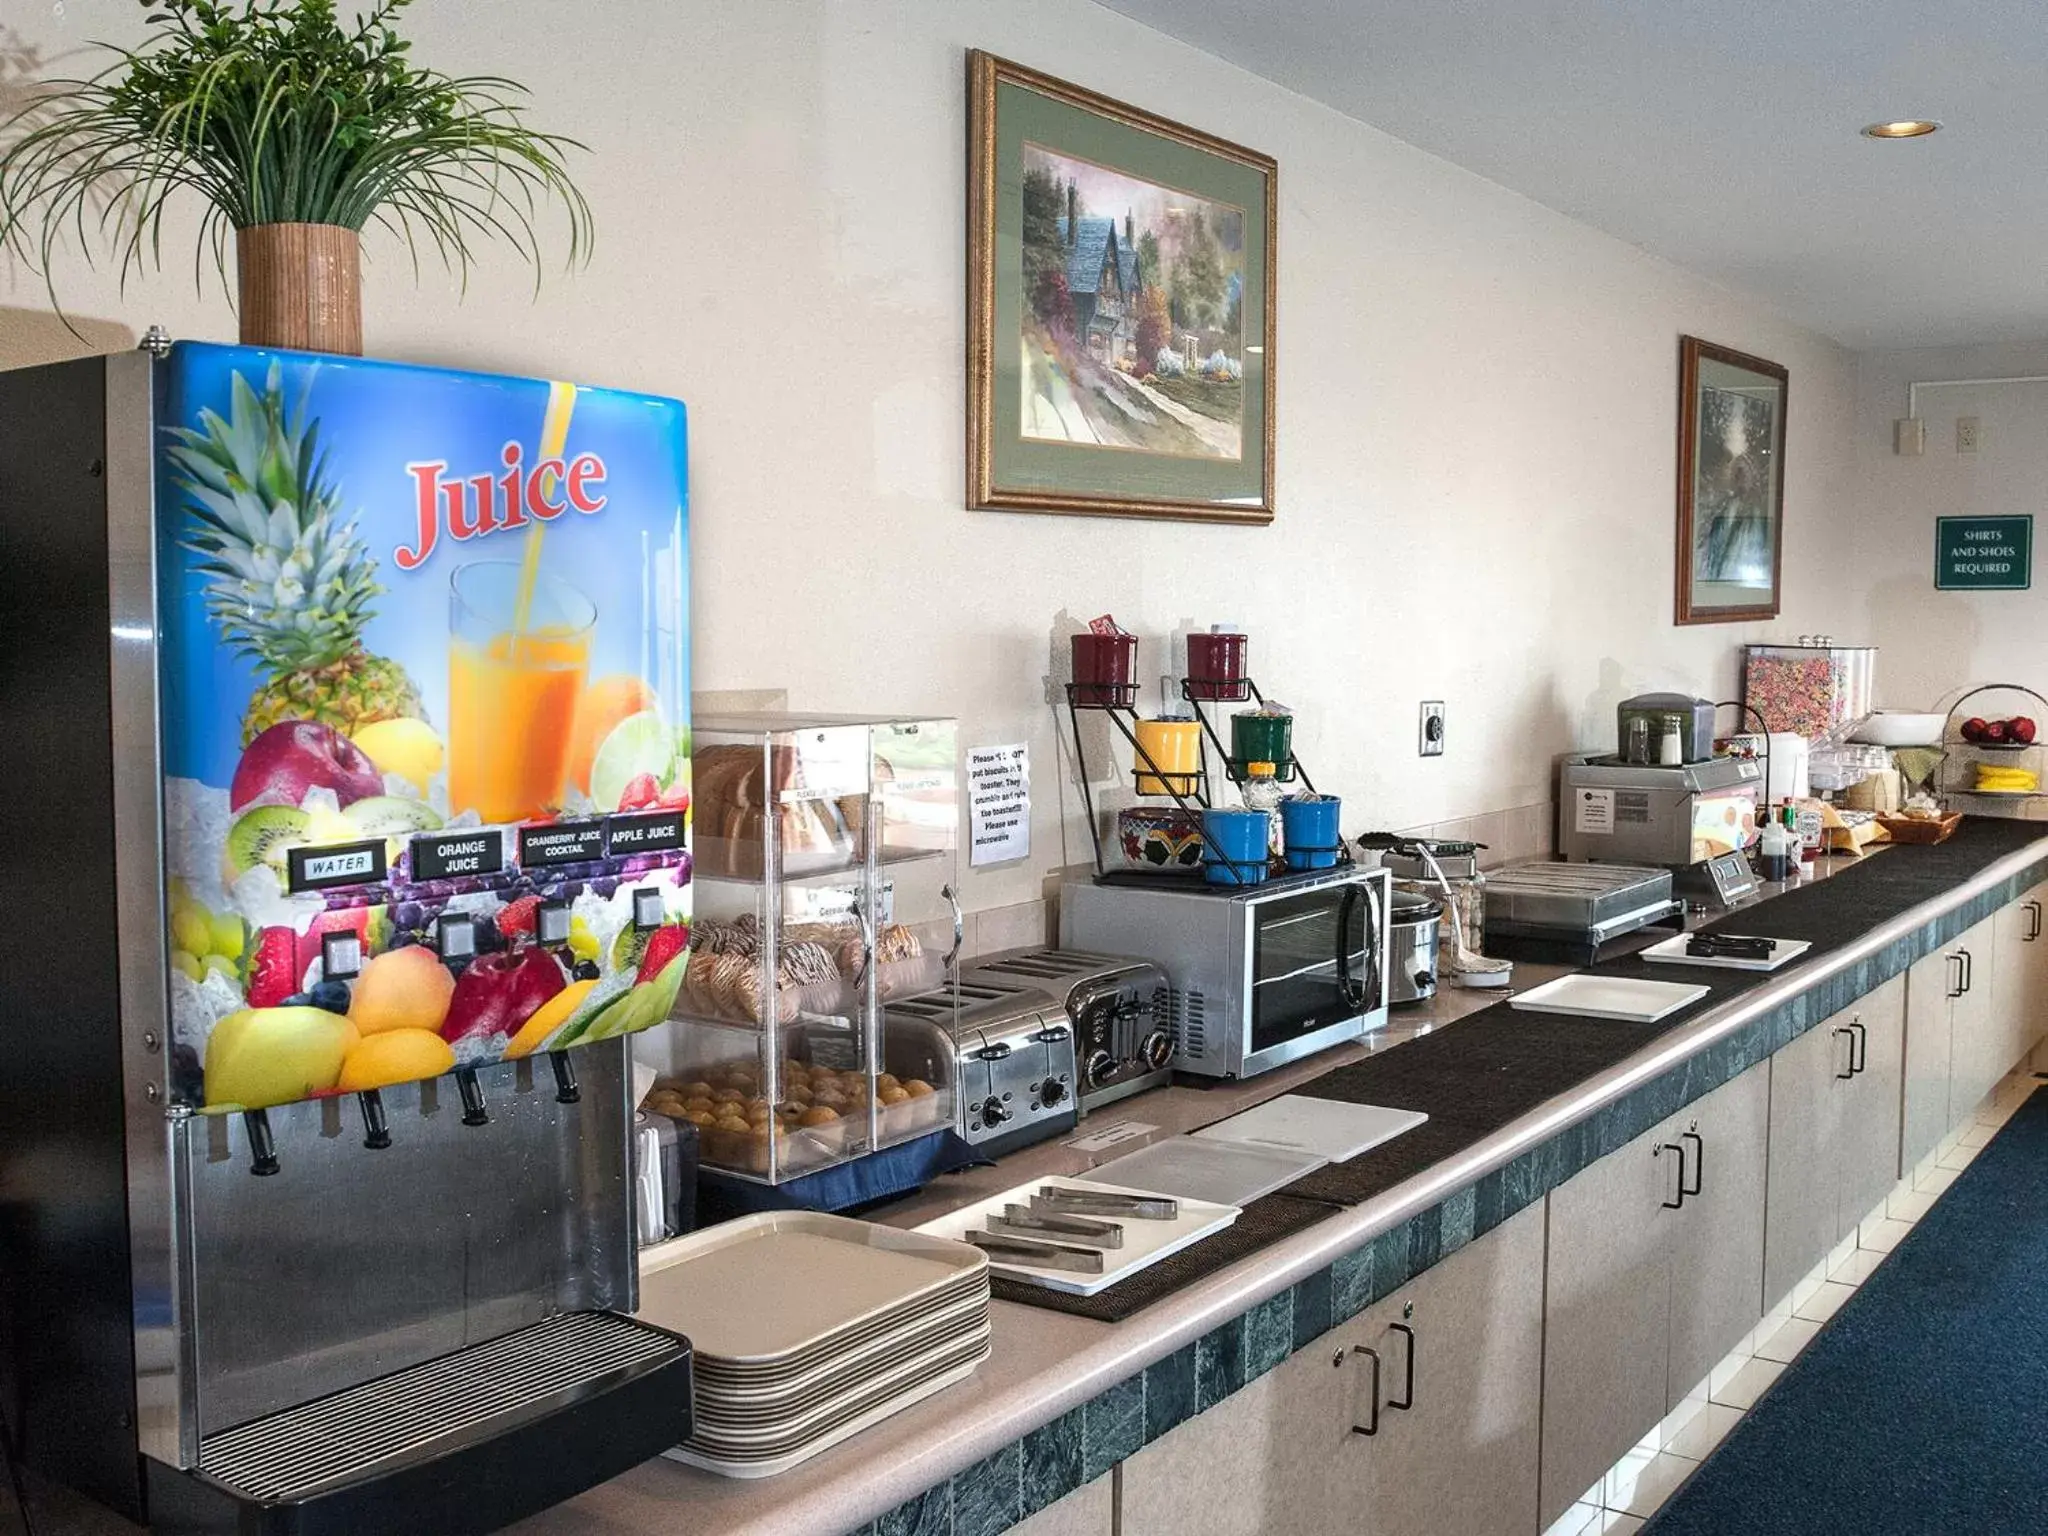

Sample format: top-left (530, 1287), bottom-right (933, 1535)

top-left (1763, 1014), bottom-right (1843, 1305)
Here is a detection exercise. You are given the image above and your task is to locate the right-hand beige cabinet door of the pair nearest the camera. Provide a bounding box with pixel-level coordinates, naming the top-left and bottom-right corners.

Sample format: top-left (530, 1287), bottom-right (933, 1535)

top-left (1331, 1202), bottom-right (1544, 1536)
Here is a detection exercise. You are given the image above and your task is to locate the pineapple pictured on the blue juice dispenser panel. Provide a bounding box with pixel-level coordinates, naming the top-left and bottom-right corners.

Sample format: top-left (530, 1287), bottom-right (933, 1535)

top-left (168, 362), bottom-right (420, 741)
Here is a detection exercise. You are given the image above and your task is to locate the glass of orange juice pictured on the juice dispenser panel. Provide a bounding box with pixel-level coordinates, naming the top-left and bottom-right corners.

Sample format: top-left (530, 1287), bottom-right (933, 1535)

top-left (449, 561), bottom-right (598, 821)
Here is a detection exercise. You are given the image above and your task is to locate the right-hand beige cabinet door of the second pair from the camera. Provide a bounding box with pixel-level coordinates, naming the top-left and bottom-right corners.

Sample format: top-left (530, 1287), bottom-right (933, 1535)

top-left (1636, 1061), bottom-right (1772, 1409)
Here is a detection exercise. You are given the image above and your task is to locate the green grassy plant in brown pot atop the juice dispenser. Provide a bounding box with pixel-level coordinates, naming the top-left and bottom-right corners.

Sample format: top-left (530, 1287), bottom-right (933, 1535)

top-left (0, 0), bottom-right (592, 352)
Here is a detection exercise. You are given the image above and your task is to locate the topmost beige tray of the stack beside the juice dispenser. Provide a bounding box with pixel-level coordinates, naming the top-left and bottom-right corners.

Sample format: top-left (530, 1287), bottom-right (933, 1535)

top-left (637, 1210), bottom-right (987, 1364)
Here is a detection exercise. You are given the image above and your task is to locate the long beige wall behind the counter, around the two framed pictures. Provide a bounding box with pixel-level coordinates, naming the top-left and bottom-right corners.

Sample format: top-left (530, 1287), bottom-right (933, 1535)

top-left (0, 0), bottom-right (1855, 907)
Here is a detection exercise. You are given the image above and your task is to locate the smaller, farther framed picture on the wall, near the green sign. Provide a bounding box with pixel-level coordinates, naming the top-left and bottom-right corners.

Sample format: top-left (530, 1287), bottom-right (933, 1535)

top-left (1677, 336), bottom-right (1786, 625)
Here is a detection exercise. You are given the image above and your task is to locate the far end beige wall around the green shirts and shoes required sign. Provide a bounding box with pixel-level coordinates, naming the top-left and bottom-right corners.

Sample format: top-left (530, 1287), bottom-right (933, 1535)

top-left (1829, 342), bottom-right (2048, 709)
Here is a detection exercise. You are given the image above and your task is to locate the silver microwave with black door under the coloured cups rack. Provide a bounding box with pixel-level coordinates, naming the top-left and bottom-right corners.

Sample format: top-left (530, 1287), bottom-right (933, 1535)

top-left (1059, 864), bottom-right (1391, 1077)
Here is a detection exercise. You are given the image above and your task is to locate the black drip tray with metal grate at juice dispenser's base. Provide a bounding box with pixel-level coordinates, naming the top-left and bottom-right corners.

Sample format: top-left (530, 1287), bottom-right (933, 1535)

top-left (152, 1311), bottom-right (690, 1536)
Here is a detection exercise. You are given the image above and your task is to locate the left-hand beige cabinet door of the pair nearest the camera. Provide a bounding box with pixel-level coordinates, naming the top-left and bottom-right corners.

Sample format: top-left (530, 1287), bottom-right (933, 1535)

top-left (1116, 1323), bottom-right (1374, 1536)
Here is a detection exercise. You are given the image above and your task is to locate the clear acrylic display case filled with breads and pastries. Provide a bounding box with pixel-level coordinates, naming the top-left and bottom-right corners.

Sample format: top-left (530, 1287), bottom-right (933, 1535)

top-left (637, 713), bottom-right (961, 1184)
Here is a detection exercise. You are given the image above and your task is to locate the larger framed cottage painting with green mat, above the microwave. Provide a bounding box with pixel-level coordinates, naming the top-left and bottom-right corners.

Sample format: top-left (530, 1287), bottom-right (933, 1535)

top-left (967, 53), bottom-right (1278, 522)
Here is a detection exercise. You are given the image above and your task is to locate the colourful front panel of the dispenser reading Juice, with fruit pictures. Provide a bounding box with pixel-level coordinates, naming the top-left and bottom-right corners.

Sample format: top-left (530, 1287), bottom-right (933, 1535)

top-left (156, 344), bottom-right (690, 1110)
